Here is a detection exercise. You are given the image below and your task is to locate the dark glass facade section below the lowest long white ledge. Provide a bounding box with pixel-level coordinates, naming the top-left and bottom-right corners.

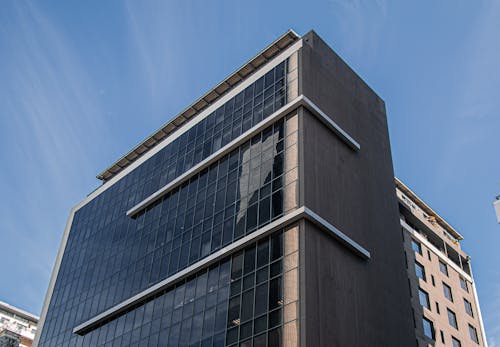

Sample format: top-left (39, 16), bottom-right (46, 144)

top-left (69, 232), bottom-right (283, 346)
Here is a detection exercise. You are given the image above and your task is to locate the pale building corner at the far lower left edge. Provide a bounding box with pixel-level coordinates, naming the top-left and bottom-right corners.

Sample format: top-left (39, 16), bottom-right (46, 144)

top-left (0, 301), bottom-right (38, 347)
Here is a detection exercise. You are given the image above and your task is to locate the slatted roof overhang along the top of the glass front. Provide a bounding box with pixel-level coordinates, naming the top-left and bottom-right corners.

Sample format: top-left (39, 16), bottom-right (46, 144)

top-left (96, 29), bottom-right (300, 183)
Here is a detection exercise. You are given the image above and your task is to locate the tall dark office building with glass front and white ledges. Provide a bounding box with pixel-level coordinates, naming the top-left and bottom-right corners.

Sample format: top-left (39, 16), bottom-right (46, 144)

top-left (37, 31), bottom-right (416, 347)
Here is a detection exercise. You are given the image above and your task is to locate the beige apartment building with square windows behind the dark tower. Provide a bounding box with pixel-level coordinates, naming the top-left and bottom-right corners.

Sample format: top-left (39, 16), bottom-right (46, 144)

top-left (396, 178), bottom-right (487, 347)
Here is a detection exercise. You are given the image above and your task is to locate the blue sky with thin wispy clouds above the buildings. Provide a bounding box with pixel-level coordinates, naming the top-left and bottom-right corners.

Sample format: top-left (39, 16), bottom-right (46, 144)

top-left (0, 0), bottom-right (500, 347)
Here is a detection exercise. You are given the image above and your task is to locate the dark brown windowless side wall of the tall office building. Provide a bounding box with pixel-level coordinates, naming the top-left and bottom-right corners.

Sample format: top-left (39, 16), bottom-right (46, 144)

top-left (300, 32), bottom-right (415, 346)
